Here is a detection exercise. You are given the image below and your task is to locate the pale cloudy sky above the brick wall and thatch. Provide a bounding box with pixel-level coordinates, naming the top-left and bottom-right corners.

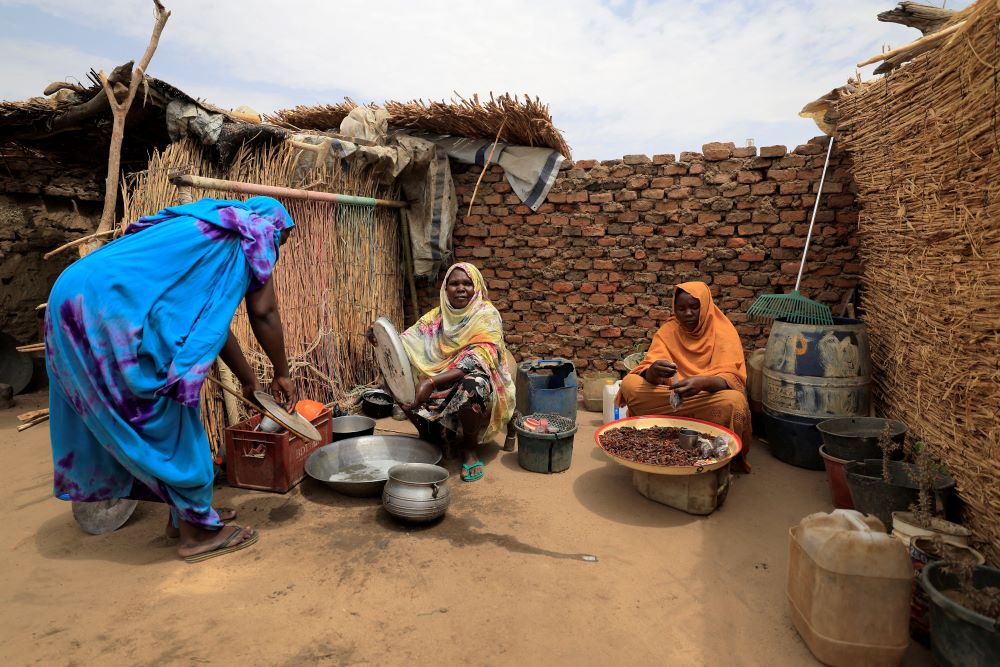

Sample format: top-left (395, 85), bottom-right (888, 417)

top-left (0, 0), bottom-right (971, 159)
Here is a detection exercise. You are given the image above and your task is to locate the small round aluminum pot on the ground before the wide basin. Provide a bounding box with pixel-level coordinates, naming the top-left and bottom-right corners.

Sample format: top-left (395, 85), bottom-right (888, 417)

top-left (382, 463), bottom-right (451, 522)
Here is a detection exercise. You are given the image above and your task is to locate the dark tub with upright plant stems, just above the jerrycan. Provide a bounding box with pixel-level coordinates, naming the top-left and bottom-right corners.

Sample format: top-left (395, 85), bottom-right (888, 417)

top-left (844, 459), bottom-right (955, 531)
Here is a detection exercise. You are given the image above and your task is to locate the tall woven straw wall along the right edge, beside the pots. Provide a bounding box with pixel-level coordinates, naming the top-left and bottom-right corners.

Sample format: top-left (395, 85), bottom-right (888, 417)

top-left (838, 0), bottom-right (1000, 564)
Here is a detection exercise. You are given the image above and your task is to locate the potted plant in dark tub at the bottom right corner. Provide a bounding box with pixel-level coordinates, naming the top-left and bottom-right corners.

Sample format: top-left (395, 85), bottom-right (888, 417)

top-left (920, 561), bottom-right (1000, 667)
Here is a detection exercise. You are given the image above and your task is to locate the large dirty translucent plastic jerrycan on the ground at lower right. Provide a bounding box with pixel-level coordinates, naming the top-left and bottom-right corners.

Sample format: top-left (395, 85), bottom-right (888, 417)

top-left (786, 510), bottom-right (913, 667)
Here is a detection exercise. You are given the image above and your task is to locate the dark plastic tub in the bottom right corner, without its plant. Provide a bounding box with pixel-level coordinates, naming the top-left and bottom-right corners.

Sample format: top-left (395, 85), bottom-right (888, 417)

top-left (920, 562), bottom-right (1000, 667)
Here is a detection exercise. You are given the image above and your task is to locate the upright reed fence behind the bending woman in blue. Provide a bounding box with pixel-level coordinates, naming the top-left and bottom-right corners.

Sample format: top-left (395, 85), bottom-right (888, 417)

top-left (122, 140), bottom-right (403, 448)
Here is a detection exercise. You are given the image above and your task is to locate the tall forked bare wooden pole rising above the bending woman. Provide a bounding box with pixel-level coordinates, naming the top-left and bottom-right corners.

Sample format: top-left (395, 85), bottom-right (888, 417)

top-left (80, 0), bottom-right (170, 257)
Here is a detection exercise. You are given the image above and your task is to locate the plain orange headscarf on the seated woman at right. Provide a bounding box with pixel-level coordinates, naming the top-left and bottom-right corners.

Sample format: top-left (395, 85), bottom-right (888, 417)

top-left (632, 282), bottom-right (747, 391)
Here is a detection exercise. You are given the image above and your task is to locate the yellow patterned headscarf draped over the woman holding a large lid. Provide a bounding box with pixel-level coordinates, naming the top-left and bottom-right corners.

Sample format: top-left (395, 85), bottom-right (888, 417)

top-left (401, 262), bottom-right (514, 439)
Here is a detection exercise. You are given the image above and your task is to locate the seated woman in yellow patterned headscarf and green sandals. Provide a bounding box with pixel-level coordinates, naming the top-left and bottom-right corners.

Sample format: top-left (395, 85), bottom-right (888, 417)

top-left (380, 262), bottom-right (514, 482)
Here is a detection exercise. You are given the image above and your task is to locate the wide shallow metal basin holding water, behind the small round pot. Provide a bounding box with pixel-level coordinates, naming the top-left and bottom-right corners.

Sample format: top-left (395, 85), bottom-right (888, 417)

top-left (306, 435), bottom-right (441, 497)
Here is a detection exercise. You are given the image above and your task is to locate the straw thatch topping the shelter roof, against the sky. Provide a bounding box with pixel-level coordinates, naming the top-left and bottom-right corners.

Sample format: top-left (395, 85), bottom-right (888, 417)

top-left (267, 95), bottom-right (572, 159)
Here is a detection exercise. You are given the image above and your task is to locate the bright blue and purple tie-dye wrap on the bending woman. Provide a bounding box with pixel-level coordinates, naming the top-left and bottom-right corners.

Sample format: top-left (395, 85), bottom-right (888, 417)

top-left (45, 197), bottom-right (294, 527)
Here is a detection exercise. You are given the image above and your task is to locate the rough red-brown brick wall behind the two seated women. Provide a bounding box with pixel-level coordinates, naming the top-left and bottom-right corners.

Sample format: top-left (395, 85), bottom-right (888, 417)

top-left (420, 138), bottom-right (861, 370)
